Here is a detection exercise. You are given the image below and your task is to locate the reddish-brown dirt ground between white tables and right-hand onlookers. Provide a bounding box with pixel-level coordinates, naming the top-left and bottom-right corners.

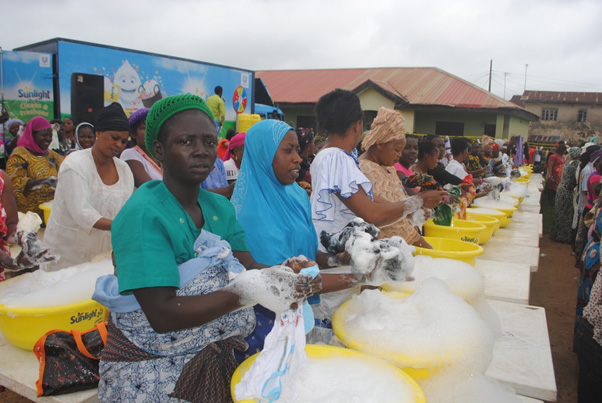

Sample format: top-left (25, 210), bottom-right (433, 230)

top-left (0, 234), bottom-right (578, 403)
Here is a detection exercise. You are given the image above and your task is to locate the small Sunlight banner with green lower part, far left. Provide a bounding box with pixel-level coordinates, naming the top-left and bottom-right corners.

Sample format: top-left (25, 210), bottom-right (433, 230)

top-left (2, 50), bottom-right (54, 123)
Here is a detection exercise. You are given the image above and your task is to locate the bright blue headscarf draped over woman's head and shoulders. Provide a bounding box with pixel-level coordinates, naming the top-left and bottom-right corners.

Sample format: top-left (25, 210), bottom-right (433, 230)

top-left (232, 119), bottom-right (318, 265)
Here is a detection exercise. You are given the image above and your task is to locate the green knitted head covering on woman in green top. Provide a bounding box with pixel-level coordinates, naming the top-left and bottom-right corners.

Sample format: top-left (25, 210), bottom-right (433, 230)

top-left (144, 94), bottom-right (214, 157)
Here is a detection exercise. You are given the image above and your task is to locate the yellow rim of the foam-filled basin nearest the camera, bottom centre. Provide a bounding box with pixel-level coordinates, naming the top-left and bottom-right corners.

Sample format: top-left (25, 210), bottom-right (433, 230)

top-left (230, 344), bottom-right (426, 403)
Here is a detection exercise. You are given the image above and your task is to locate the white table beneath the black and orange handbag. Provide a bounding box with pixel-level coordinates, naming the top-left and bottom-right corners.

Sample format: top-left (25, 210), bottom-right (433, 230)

top-left (0, 333), bottom-right (99, 403)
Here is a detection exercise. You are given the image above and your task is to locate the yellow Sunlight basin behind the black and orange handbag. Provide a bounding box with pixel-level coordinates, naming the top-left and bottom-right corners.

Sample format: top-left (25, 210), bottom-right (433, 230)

top-left (0, 299), bottom-right (108, 350)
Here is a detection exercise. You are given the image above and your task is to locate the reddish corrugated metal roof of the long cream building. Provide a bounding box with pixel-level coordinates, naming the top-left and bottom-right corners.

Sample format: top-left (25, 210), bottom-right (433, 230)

top-left (256, 67), bottom-right (522, 109)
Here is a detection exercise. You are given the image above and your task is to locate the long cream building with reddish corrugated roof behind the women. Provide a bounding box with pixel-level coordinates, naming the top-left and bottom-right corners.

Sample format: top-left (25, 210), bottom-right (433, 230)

top-left (256, 67), bottom-right (538, 138)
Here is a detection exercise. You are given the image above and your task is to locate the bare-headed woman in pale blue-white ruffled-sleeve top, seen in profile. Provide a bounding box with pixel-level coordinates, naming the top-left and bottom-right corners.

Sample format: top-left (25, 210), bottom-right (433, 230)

top-left (310, 89), bottom-right (446, 243)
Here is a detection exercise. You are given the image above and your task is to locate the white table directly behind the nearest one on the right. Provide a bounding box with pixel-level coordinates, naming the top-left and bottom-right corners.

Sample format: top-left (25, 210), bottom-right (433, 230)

top-left (475, 258), bottom-right (531, 304)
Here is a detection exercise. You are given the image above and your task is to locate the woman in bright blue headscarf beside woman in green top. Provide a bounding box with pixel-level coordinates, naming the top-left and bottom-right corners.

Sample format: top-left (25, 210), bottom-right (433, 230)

top-left (232, 119), bottom-right (358, 355)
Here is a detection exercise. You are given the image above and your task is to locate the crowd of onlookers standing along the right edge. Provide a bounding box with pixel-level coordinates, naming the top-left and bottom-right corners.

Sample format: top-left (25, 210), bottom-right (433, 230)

top-left (541, 141), bottom-right (602, 402)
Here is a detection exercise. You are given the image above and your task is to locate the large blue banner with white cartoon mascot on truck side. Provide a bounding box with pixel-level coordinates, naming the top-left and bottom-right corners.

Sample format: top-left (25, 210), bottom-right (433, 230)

top-left (58, 42), bottom-right (253, 120)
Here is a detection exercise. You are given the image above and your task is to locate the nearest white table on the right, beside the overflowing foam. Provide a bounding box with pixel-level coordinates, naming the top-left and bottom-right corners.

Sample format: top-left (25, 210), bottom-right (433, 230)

top-left (486, 300), bottom-right (557, 402)
